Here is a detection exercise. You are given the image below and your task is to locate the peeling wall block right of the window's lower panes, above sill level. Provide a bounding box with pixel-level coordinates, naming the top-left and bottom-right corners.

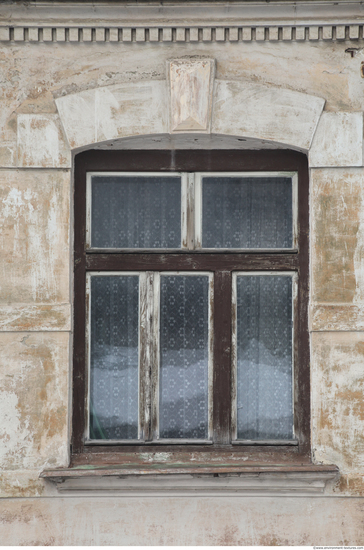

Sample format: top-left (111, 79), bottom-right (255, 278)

top-left (312, 332), bottom-right (364, 488)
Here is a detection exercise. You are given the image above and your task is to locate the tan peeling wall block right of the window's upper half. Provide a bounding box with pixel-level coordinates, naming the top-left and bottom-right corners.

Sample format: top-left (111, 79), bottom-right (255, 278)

top-left (310, 168), bottom-right (363, 306)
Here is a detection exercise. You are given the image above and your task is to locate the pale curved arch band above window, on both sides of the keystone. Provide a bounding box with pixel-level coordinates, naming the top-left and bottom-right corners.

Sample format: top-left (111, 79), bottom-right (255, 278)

top-left (56, 72), bottom-right (325, 152)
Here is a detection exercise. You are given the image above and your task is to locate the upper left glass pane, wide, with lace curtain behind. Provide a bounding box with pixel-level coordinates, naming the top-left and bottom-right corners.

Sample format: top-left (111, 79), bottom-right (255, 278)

top-left (91, 175), bottom-right (181, 248)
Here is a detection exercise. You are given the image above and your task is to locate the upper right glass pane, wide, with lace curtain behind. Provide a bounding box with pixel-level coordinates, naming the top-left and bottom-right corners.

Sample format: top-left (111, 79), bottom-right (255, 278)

top-left (202, 176), bottom-right (292, 248)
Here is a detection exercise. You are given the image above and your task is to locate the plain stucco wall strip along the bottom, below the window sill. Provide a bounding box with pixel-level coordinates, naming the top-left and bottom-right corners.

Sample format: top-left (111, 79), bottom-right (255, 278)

top-left (0, 497), bottom-right (364, 546)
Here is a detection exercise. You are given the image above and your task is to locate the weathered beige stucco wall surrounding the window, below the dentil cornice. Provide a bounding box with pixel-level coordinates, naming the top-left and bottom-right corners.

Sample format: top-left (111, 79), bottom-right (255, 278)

top-left (0, 2), bottom-right (364, 545)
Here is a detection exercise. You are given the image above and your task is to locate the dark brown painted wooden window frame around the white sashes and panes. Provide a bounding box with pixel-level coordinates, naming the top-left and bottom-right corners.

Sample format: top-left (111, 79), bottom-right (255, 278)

top-left (71, 150), bottom-right (311, 466)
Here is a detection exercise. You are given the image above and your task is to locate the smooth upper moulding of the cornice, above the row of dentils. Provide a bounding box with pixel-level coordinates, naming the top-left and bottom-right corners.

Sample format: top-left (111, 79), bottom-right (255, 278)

top-left (0, 0), bottom-right (364, 25)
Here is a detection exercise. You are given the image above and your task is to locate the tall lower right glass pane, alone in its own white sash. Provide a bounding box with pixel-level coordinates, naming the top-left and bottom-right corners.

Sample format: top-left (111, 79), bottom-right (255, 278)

top-left (237, 275), bottom-right (293, 439)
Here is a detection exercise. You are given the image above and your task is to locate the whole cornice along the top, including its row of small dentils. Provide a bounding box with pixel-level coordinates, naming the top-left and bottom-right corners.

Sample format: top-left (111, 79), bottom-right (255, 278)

top-left (0, 0), bottom-right (364, 43)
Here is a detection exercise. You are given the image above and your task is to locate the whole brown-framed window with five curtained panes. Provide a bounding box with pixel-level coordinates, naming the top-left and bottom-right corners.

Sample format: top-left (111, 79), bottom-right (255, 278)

top-left (72, 150), bottom-right (310, 463)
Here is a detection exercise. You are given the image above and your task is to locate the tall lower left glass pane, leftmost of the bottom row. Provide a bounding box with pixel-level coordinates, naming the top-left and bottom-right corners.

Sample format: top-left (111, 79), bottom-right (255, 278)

top-left (90, 276), bottom-right (139, 439)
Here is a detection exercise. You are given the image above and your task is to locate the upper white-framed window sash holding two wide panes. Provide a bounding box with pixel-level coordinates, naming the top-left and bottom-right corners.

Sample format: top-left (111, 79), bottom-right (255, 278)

top-left (86, 172), bottom-right (298, 252)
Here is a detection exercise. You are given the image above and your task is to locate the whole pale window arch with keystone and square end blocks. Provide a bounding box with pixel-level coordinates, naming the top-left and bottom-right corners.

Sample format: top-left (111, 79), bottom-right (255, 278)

top-left (17, 63), bottom-right (363, 168)
